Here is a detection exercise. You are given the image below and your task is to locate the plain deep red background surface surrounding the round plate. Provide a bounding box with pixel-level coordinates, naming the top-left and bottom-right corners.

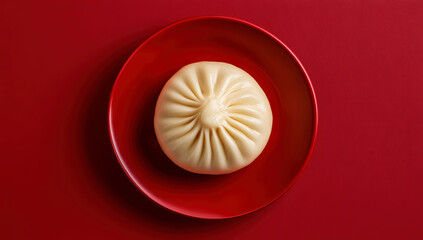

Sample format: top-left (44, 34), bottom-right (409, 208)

top-left (0, 0), bottom-right (423, 239)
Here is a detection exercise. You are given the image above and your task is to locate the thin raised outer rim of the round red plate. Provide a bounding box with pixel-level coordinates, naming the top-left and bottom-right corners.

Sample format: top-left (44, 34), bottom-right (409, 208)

top-left (108, 15), bottom-right (318, 219)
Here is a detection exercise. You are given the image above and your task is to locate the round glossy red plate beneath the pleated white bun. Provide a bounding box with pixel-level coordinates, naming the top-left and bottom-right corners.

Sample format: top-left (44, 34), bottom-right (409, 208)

top-left (109, 17), bottom-right (317, 219)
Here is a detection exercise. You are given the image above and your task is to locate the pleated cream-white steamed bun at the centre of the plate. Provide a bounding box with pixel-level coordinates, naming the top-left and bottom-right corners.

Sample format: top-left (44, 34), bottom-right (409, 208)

top-left (154, 62), bottom-right (273, 175)
